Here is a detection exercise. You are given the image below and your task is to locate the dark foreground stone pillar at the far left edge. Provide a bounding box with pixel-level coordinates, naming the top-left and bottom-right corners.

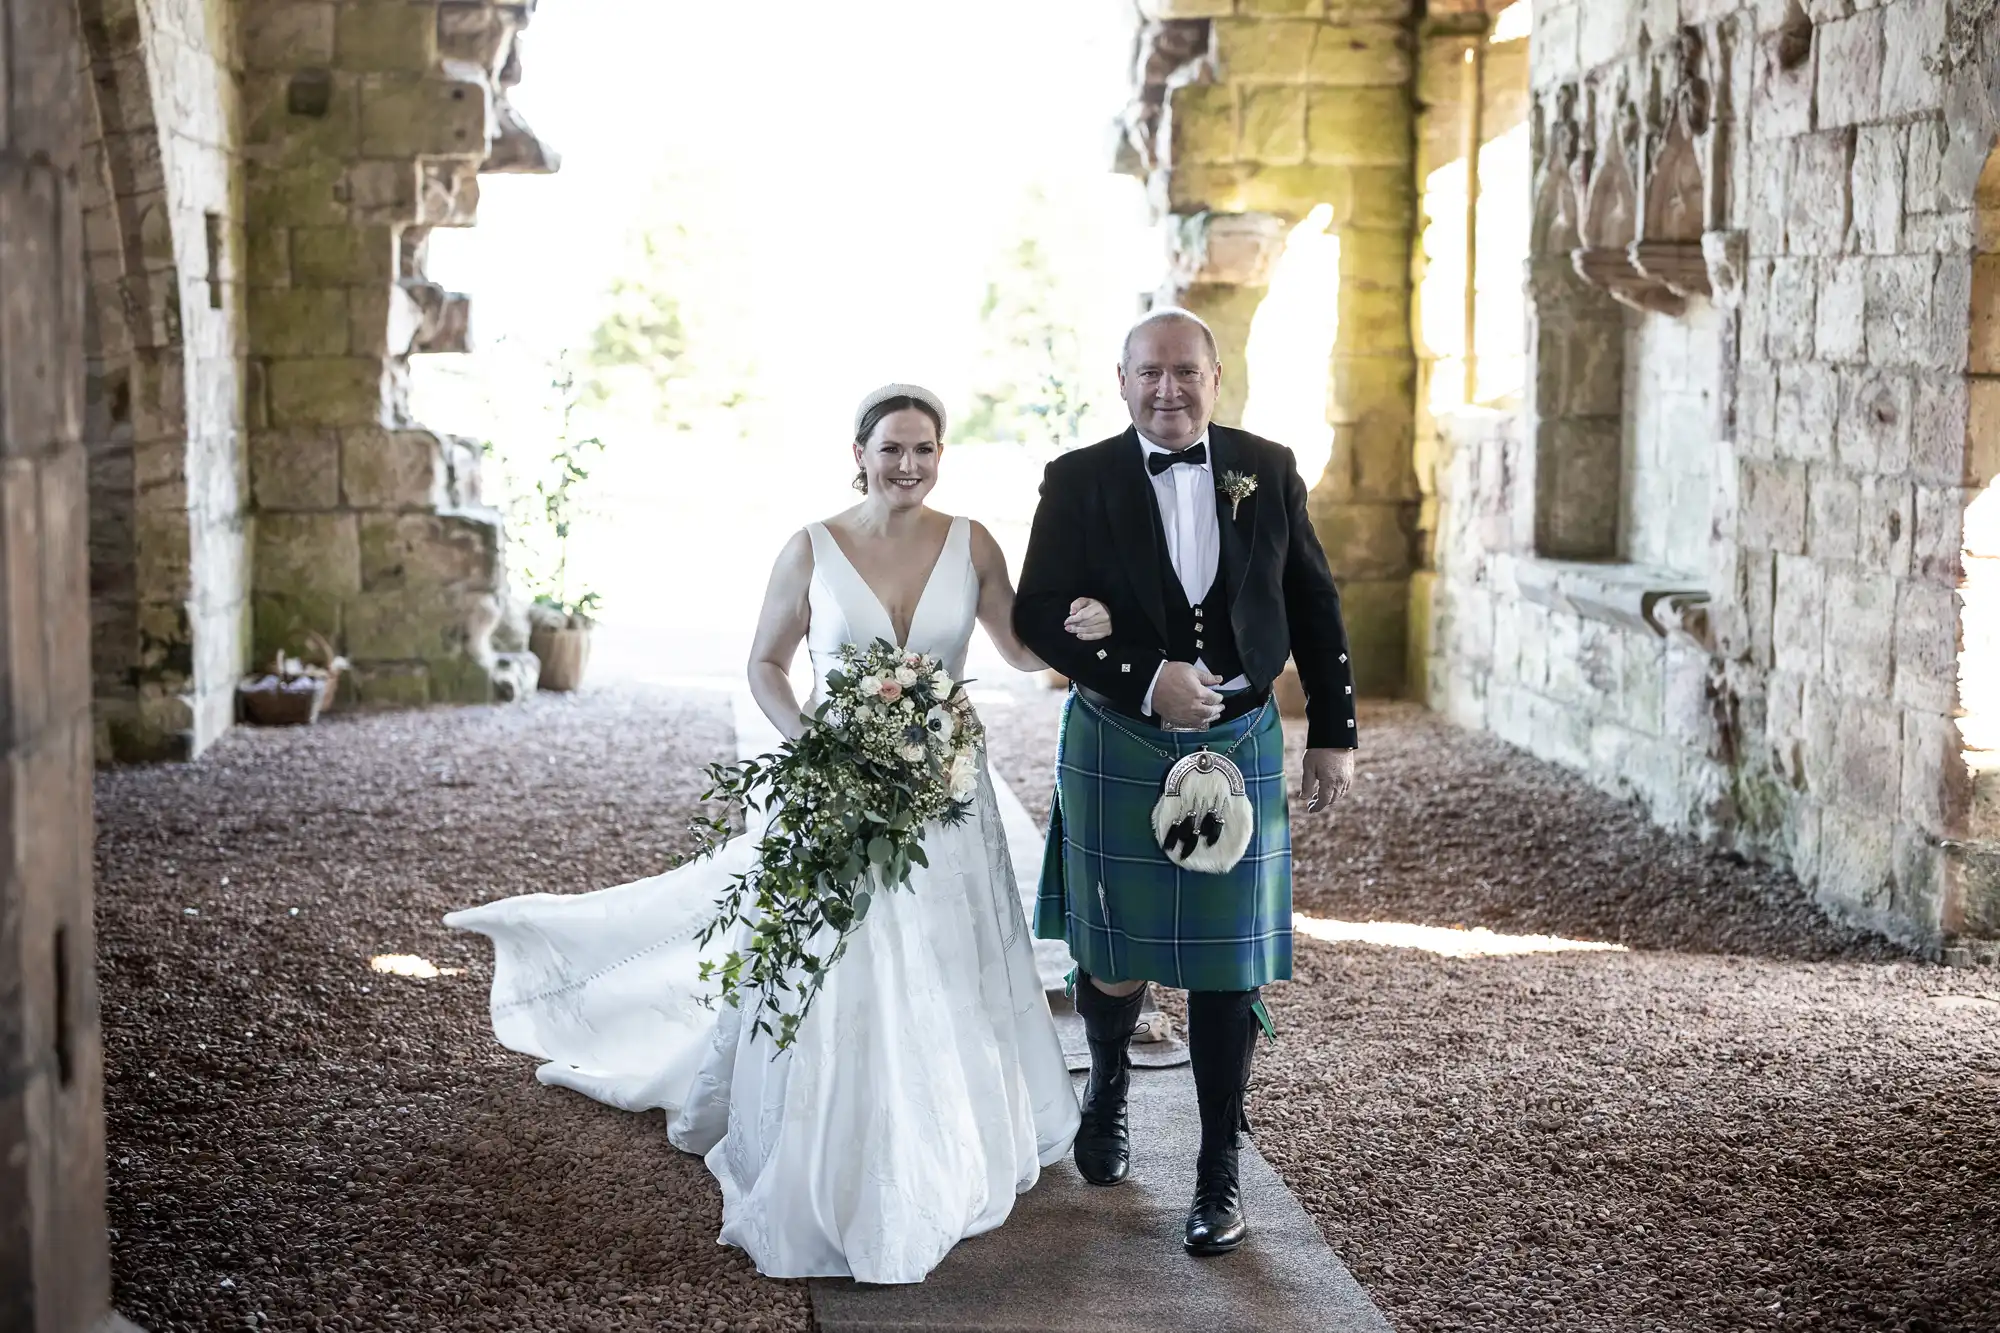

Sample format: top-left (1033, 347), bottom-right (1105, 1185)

top-left (0, 0), bottom-right (127, 1333)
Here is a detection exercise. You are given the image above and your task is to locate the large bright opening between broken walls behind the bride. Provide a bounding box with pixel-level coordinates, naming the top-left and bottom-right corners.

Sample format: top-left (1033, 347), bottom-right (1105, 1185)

top-left (412, 0), bottom-right (1160, 679)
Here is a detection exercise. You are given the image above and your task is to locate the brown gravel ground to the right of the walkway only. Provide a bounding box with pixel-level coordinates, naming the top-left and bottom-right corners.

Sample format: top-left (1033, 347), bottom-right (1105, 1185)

top-left (988, 701), bottom-right (2000, 1333)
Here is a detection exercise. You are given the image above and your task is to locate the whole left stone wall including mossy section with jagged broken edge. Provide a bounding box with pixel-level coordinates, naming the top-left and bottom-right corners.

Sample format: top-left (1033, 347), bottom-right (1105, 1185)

top-left (76, 0), bottom-right (556, 759)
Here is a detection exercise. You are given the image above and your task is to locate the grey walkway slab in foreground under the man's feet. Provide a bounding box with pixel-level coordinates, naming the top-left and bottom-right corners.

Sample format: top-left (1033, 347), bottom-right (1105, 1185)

top-left (812, 1067), bottom-right (1390, 1333)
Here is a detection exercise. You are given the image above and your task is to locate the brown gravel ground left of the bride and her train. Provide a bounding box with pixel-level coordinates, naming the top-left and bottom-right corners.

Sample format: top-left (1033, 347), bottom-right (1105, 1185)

top-left (98, 691), bottom-right (808, 1333)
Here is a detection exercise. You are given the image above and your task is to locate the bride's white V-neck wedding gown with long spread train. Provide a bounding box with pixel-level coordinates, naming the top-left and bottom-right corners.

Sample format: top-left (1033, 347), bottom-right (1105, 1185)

top-left (444, 518), bottom-right (1076, 1283)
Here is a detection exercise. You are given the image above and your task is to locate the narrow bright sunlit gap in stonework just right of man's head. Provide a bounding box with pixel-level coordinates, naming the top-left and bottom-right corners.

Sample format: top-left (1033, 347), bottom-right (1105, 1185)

top-left (1244, 204), bottom-right (1340, 486)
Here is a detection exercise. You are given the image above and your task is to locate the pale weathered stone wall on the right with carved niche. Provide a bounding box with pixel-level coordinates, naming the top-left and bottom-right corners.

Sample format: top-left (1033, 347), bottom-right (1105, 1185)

top-left (1426, 0), bottom-right (2000, 947)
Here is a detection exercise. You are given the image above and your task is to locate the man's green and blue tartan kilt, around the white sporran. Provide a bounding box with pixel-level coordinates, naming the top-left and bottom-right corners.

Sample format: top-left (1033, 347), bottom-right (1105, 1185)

top-left (1034, 691), bottom-right (1292, 991)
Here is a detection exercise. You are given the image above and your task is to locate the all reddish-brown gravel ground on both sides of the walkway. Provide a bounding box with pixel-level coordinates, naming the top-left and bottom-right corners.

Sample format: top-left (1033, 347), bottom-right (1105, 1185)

top-left (98, 687), bottom-right (2000, 1333)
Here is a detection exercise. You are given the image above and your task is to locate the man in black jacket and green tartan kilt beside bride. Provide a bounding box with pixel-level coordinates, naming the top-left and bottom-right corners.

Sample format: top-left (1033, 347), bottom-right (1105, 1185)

top-left (1014, 310), bottom-right (1356, 1255)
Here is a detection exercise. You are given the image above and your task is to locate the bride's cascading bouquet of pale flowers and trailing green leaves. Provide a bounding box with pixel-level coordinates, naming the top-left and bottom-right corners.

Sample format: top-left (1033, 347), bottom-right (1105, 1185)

top-left (700, 638), bottom-right (984, 1051)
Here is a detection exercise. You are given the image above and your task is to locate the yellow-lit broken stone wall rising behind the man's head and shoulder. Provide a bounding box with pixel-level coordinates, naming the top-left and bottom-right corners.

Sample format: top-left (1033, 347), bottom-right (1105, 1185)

top-left (1122, 0), bottom-right (1418, 695)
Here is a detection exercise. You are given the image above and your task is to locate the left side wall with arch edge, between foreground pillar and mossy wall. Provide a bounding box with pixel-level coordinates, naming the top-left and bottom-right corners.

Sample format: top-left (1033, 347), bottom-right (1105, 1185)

top-left (78, 0), bottom-right (248, 759)
